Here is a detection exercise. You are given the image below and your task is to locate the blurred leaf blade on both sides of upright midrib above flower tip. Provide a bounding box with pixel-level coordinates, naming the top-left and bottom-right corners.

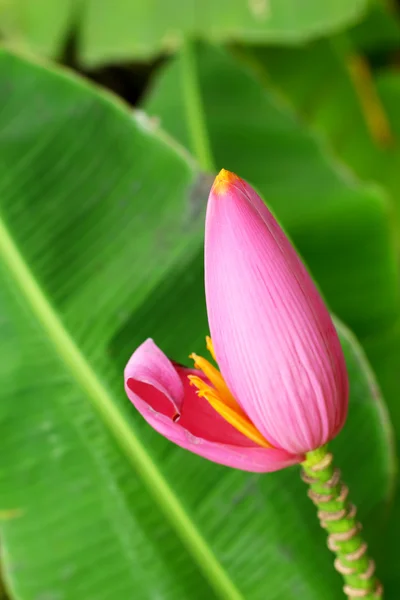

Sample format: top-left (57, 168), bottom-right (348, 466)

top-left (144, 39), bottom-right (398, 336)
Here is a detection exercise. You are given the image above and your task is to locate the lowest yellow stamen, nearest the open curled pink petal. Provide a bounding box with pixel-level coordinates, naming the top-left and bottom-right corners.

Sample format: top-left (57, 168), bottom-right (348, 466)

top-left (188, 375), bottom-right (271, 448)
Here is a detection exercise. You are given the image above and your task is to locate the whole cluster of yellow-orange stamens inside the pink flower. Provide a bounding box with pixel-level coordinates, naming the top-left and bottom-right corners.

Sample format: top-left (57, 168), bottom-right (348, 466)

top-left (188, 337), bottom-right (271, 448)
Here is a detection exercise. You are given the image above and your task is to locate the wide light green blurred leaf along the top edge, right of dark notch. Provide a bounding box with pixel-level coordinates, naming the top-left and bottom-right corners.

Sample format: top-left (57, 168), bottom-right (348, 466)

top-left (81, 0), bottom-right (367, 64)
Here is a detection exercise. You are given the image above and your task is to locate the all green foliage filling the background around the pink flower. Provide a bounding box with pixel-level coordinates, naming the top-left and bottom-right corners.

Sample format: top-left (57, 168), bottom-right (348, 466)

top-left (0, 0), bottom-right (400, 600)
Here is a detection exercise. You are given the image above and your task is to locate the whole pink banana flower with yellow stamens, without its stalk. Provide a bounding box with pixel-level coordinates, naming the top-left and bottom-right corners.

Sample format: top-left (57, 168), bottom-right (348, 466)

top-left (125, 169), bottom-right (348, 472)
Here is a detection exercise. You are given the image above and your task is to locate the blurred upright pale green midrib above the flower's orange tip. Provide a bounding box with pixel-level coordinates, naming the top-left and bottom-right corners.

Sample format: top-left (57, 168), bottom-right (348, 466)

top-left (181, 39), bottom-right (215, 171)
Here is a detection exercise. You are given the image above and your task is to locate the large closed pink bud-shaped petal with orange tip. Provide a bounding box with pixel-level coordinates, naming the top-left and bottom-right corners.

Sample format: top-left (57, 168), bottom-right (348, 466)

top-left (205, 171), bottom-right (348, 453)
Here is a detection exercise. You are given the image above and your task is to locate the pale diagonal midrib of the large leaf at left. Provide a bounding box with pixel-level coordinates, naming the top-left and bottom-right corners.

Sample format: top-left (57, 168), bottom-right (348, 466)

top-left (0, 219), bottom-right (243, 600)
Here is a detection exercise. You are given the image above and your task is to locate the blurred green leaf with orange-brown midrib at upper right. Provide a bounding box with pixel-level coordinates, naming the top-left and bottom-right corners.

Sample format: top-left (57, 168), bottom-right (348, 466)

top-left (254, 35), bottom-right (400, 232)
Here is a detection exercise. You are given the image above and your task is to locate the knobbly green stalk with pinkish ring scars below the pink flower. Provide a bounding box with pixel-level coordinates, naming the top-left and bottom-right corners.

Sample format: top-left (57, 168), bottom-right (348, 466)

top-left (302, 446), bottom-right (383, 600)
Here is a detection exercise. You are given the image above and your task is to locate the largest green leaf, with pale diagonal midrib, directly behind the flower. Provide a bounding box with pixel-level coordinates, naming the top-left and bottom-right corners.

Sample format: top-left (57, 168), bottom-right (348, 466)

top-left (0, 52), bottom-right (394, 600)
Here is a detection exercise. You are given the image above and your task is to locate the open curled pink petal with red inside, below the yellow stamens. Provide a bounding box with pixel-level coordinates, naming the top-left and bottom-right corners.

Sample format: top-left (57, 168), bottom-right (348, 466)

top-left (125, 339), bottom-right (302, 472)
